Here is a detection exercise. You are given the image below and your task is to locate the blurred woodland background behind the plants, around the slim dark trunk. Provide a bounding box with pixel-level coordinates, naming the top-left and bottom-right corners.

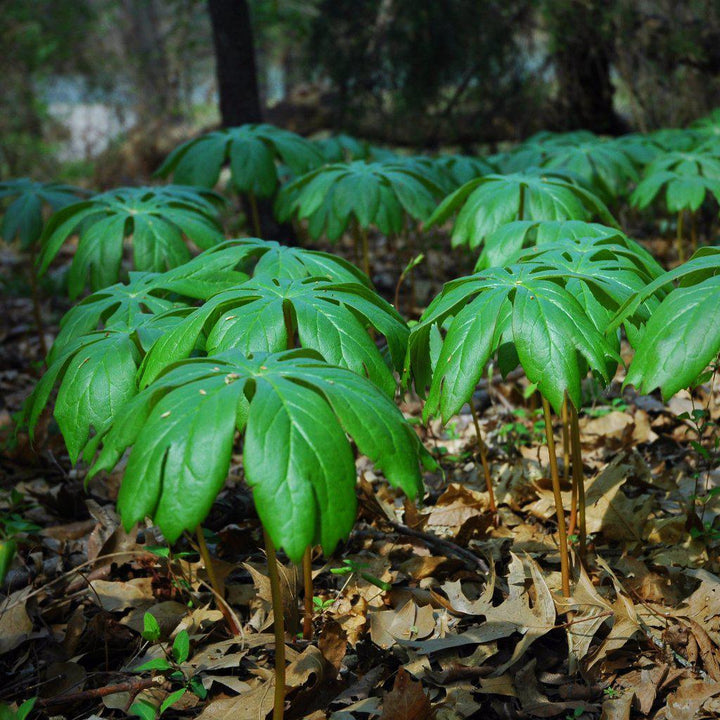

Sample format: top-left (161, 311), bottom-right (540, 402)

top-left (0, 0), bottom-right (720, 178)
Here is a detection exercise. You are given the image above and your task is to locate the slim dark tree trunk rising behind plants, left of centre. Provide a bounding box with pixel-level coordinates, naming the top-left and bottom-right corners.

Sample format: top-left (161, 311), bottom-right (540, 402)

top-left (208, 0), bottom-right (262, 127)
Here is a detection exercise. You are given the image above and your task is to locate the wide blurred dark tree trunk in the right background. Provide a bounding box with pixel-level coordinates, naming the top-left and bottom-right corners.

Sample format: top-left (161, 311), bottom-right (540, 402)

top-left (549, 0), bottom-right (627, 135)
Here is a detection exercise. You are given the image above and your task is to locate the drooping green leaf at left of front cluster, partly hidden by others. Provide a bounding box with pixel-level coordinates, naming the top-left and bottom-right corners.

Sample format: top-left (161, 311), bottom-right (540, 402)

top-left (19, 315), bottom-right (187, 463)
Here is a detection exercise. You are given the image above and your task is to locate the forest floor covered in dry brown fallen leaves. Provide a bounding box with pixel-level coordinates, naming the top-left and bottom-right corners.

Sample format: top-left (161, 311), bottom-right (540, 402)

top-left (0, 231), bottom-right (720, 720)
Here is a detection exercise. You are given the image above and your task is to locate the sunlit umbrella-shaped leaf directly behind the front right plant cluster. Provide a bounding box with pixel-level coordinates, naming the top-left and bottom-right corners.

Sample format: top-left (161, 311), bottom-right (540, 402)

top-left (426, 171), bottom-right (617, 248)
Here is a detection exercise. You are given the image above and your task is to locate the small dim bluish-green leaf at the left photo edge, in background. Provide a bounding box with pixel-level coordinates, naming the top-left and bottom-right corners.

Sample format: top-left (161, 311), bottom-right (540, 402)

top-left (0, 178), bottom-right (85, 248)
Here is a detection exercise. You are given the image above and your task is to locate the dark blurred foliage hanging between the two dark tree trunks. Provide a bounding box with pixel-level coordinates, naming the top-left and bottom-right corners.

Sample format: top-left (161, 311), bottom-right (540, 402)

top-left (309, 0), bottom-right (533, 142)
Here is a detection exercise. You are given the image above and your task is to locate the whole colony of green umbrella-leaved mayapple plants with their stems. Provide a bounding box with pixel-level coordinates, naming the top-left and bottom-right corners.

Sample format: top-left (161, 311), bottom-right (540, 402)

top-left (0, 115), bottom-right (720, 720)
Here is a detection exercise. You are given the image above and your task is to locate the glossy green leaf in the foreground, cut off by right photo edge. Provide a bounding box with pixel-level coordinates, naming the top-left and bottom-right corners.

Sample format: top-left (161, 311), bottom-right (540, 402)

top-left (625, 276), bottom-right (720, 400)
